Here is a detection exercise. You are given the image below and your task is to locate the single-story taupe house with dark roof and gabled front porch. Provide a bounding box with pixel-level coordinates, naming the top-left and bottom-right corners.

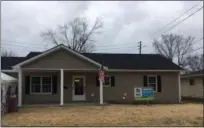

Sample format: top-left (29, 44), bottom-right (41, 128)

top-left (2, 45), bottom-right (182, 106)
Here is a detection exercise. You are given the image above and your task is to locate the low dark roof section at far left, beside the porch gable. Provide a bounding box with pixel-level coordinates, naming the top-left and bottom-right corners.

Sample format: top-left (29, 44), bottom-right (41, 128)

top-left (1, 57), bottom-right (25, 70)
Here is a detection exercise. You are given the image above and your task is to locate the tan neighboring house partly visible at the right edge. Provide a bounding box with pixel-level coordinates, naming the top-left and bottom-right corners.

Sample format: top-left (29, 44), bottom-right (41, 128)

top-left (181, 70), bottom-right (204, 98)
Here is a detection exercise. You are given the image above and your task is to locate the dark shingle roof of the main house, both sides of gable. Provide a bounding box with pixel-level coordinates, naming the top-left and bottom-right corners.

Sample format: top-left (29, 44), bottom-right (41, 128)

top-left (2, 52), bottom-right (182, 70)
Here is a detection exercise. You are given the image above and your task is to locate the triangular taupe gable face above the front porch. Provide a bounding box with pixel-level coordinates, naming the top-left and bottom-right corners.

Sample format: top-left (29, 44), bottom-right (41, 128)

top-left (21, 49), bottom-right (99, 70)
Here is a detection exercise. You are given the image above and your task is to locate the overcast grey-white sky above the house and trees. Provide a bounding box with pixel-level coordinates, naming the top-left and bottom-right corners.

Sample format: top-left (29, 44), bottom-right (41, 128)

top-left (1, 1), bottom-right (203, 56)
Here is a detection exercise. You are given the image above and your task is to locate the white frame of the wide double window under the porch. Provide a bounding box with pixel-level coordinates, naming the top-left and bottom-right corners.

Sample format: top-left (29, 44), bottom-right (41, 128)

top-left (30, 76), bottom-right (53, 94)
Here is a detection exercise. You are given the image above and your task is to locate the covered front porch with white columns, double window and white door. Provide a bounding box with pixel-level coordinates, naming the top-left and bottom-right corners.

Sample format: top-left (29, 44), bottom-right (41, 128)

top-left (18, 69), bottom-right (103, 107)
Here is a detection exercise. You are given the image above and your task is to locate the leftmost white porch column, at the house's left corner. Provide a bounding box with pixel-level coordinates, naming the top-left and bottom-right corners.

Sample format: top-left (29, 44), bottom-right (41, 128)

top-left (18, 68), bottom-right (22, 107)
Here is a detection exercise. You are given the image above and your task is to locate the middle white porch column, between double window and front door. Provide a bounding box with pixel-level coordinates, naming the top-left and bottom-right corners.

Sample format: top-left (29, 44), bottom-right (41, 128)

top-left (60, 69), bottom-right (64, 105)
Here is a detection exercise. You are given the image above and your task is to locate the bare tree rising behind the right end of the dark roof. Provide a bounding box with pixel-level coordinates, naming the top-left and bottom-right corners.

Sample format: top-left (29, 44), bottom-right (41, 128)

top-left (153, 34), bottom-right (194, 67)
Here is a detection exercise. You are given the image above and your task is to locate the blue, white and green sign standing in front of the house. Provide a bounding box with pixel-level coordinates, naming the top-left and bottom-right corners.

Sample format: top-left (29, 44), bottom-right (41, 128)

top-left (134, 88), bottom-right (154, 100)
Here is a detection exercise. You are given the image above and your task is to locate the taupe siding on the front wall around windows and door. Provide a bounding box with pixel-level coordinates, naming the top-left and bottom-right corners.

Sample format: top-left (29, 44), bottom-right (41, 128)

top-left (23, 71), bottom-right (179, 104)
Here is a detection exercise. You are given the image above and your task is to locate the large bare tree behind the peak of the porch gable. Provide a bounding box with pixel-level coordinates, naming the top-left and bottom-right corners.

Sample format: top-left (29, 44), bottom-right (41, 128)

top-left (41, 17), bottom-right (103, 52)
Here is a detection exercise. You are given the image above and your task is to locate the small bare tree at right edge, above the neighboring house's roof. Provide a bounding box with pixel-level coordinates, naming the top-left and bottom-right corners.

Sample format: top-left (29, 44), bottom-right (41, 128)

top-left (185, 54), bottom-right (204, 71)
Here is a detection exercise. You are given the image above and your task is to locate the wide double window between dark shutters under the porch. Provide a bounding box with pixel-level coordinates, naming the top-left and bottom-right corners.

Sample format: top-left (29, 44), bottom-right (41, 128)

top-left (31, 76), bottom-right (52, 93)
